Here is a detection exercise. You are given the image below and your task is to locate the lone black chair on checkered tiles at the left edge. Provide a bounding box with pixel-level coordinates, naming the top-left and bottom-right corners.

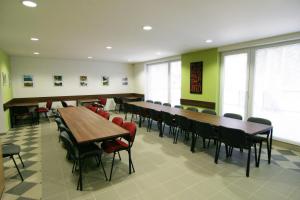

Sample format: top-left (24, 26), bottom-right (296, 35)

top-left (2, 144), bottom-right (25, 181)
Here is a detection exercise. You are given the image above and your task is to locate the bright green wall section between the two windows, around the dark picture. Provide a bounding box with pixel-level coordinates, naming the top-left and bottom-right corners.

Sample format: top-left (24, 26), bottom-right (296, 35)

top-left (181, 48), bottom-right (220, 112)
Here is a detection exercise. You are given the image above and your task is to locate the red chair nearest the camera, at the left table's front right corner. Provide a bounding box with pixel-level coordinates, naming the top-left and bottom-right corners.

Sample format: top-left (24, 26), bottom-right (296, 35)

top-left (101, 122), bottom-right (136, 180)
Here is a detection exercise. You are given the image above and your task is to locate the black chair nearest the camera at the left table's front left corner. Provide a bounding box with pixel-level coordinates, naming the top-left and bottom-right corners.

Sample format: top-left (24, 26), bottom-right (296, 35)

top-left (60, 131), bottom-right (107, 190)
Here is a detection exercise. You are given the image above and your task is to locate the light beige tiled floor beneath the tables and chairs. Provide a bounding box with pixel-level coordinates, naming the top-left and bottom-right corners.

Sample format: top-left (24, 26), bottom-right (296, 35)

top-left (1, 111), bottom-right (300, 200)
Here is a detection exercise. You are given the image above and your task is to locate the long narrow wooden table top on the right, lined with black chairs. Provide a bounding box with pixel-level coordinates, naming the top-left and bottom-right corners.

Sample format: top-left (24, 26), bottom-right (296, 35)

top-left (129, 101), bottom-right (273, 135)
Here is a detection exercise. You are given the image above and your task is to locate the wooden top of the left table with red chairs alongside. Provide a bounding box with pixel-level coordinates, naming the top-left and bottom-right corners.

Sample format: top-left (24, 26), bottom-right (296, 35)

top-left (58, 107), bottom-right (129, 144)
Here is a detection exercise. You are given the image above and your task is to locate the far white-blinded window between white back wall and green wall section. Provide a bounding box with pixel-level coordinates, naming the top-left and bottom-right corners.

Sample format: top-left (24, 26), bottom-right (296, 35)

top-left (146, 61), bottom-right (181, 105)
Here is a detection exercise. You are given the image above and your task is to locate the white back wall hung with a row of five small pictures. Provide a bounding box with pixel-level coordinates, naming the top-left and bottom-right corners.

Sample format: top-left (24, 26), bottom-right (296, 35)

top-left (11, 56), bottom-right (135, 98)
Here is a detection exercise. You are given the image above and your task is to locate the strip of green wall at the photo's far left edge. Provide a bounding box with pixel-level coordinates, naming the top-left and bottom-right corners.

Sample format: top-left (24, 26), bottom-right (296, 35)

top-left (0, 49), bottom-right (12, 130)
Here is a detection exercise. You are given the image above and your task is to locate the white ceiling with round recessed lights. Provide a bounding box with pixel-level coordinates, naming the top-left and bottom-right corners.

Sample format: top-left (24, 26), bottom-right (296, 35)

top-left (0, 0), bottom-right (300, 62)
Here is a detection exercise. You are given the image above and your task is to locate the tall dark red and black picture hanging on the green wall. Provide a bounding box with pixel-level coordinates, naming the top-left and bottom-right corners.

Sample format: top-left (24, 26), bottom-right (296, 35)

top-left (190, 61), bottom-right (203, 94)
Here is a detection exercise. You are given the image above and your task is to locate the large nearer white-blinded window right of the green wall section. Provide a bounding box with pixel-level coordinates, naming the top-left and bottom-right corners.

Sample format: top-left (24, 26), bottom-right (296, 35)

top-left (221, 42), bottom-right (300, 144)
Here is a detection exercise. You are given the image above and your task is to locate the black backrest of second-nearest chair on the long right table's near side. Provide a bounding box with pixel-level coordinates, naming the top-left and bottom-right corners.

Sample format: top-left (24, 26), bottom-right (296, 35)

top-left (192, 121), bottom-right (217, 138)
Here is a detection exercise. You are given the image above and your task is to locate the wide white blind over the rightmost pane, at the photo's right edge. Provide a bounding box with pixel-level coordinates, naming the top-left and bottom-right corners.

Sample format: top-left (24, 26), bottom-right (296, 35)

top-left (252, 43), bottom-right (300, 144)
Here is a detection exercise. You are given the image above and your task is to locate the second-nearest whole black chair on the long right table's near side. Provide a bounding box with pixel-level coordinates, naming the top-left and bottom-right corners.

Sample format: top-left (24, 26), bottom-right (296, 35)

top-left (191, 121), bottom-right (218, 151)
